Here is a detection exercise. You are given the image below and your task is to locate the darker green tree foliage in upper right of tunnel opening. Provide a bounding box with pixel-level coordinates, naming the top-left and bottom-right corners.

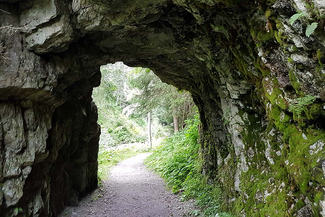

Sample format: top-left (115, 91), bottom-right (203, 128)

top-left (129, 68), bottom-right (195, 129)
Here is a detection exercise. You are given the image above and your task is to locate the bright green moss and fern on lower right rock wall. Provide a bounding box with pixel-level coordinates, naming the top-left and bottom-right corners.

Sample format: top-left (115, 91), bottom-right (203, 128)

top-left (264, 80), bottom-right (325, 216)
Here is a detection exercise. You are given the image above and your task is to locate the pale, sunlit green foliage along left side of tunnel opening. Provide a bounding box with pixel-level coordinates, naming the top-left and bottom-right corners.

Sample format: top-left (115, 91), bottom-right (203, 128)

top-left (93, 66), bottom-right (145, 146)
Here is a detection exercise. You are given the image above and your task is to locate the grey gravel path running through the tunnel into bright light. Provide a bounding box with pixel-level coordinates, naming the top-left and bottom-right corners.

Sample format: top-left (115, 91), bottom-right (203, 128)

top-left (61, 153), bottom-right (194, 217)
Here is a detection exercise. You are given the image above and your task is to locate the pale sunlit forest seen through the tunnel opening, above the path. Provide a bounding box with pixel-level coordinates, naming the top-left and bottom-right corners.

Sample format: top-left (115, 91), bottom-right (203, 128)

top-left (93, 62), bottom-right (196, 146)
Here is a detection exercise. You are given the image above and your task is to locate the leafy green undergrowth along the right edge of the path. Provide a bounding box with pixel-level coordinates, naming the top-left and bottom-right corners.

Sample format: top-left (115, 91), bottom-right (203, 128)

top-left (146, 115), bottom-right (231, 217)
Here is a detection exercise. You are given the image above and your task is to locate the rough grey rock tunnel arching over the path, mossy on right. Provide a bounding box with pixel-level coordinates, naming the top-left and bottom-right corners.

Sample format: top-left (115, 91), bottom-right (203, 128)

top-left (0, 0), bottom-right (325, 217)
